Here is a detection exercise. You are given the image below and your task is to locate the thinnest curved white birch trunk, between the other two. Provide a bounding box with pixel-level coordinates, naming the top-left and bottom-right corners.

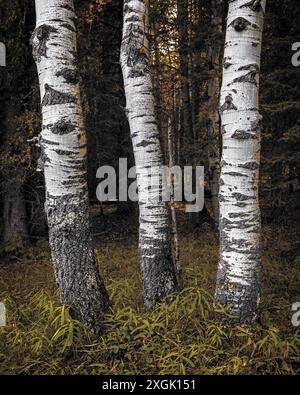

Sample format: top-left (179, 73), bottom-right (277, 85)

top-left (121, 0), bottom-right (177, 308)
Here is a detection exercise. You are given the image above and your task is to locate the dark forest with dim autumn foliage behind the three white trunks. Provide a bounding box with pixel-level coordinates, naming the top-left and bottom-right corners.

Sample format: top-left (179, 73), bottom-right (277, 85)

top-left (0, 0), bottom-right (300, 248)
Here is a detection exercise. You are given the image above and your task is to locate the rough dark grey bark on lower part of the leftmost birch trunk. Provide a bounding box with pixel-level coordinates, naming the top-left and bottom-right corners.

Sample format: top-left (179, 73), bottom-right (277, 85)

top-left (47, 198), bottom-right (109, 334)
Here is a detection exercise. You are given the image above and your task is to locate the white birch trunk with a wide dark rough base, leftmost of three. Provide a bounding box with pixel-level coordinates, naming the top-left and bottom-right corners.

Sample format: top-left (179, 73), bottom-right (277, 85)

top-left (32, 0), bottom-right (109, 333)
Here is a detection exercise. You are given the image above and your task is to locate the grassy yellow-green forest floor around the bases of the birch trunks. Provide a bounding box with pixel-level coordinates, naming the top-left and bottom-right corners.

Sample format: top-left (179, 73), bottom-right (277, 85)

top-left (0, 209), bottom-right (300, 374)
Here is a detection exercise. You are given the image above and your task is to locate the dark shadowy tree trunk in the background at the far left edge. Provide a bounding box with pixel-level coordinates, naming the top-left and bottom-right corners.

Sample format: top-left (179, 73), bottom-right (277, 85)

top-left (0, 0), bottom-right (30, 242)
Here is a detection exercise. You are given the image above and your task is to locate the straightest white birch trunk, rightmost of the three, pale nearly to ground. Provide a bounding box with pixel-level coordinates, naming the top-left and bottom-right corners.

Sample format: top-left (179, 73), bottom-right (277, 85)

top-left (216, 0), bottom-right (266, 323)
